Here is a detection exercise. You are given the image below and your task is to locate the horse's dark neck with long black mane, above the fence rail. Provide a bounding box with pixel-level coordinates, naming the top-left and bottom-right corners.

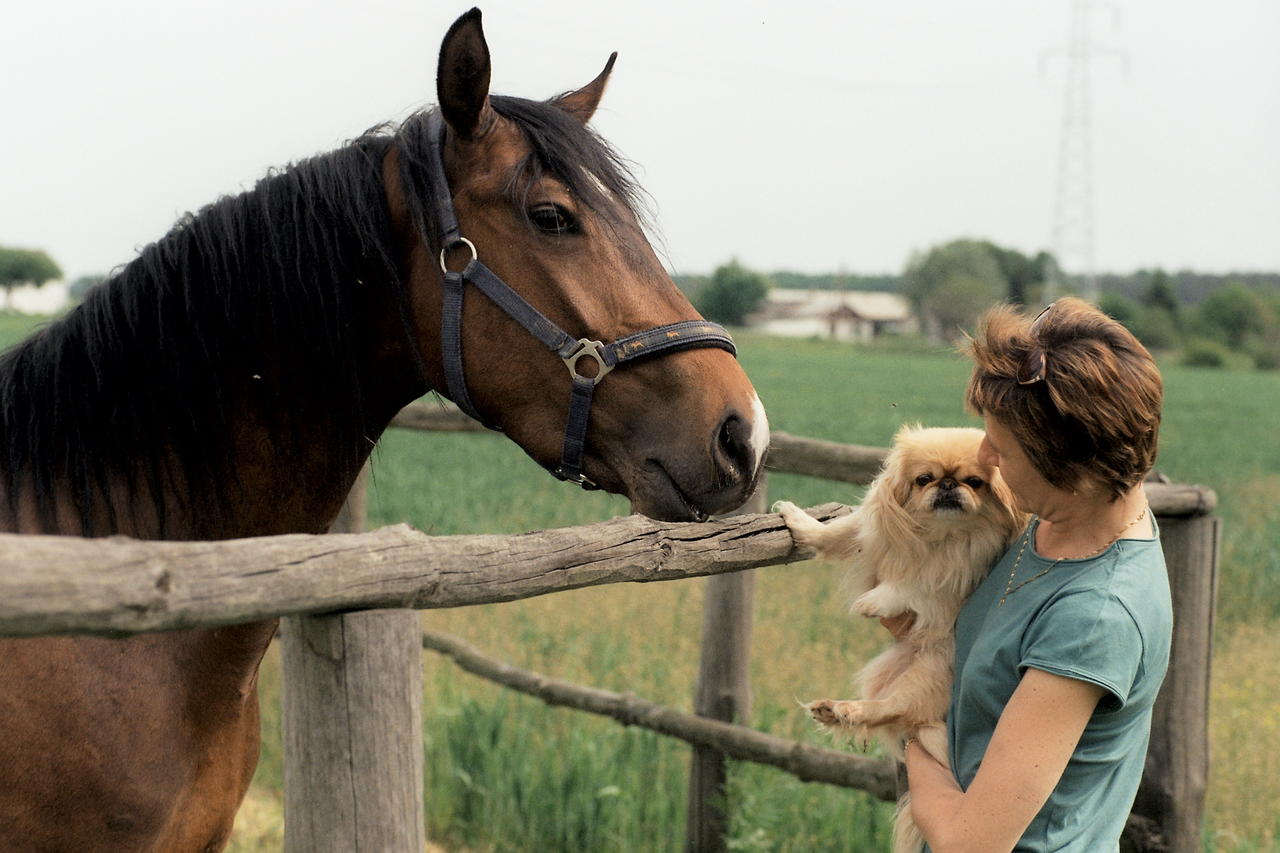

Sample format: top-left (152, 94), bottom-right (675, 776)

top-left (0, 139), bottom-right (425, 539)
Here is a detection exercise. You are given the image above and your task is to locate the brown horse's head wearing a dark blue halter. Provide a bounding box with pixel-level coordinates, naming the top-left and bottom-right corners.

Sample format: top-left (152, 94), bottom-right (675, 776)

top-left (384, 9), bottom-right (768, 520)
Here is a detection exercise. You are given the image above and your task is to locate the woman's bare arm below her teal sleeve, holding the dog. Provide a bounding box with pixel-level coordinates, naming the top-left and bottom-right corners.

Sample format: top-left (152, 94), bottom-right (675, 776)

top-left (906, 669), bottom-right (1105, 853)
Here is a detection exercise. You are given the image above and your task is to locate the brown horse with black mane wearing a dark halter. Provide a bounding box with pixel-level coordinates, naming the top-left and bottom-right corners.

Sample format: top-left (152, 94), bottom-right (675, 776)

top-left (0, 9), bottom-right (768, 853)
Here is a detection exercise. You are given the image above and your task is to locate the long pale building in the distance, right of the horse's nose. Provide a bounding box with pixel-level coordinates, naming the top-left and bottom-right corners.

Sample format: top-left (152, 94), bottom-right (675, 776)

top-left (746, 287), bottom-right (916, 342)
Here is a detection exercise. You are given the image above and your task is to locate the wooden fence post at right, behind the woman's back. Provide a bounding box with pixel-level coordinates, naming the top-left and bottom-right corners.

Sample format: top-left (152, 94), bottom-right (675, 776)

top-left (1124, 514), bottom-right (1221, 853)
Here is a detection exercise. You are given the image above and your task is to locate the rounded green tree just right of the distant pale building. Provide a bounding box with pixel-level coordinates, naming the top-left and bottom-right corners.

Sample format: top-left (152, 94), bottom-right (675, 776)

top-left (902, 240), bottom-right (1009, 339)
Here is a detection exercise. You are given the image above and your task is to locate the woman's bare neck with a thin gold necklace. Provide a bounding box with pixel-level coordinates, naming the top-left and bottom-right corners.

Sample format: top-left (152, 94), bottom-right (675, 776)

top-left (1034, 484), bottom-right (1153, 560)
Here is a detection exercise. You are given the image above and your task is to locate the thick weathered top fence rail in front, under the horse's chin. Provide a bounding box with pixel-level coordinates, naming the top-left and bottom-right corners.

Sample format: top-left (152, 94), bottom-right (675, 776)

top-left (0, 503), bottom-right (847, 637)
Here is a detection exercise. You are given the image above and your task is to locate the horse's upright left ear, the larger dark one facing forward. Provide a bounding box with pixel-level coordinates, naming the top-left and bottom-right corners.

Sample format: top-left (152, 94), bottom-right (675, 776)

top-left (435, 9), bottom-right (494, 138)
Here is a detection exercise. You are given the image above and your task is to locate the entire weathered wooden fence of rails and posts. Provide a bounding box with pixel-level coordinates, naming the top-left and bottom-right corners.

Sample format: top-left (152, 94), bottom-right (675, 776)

top-left (0, 403), bottom-right (1219, 853)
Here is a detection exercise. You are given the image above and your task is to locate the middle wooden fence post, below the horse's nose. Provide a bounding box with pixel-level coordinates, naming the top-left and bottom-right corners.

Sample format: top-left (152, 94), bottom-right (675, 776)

top-left (685, 474), bottom-right (768, 853)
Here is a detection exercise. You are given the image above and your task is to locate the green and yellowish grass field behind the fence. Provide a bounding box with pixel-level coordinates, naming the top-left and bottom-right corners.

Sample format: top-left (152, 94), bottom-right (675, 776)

top-left (0, 315), bottom-right (1280, 853)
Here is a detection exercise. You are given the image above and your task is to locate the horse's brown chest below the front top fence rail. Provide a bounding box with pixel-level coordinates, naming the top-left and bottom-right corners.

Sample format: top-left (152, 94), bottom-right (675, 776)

top-left (0, 622), bottom-right (259, 853)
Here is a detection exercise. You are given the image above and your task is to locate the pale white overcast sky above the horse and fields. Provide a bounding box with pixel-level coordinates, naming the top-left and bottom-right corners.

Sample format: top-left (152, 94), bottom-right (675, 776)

top-left (0, 0), bottom-right (1280, 278)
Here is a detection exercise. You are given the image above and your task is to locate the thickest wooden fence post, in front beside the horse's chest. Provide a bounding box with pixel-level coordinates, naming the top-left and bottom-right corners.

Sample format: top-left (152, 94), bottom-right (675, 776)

top-left (282, 469), bottom-right (426, 853)
